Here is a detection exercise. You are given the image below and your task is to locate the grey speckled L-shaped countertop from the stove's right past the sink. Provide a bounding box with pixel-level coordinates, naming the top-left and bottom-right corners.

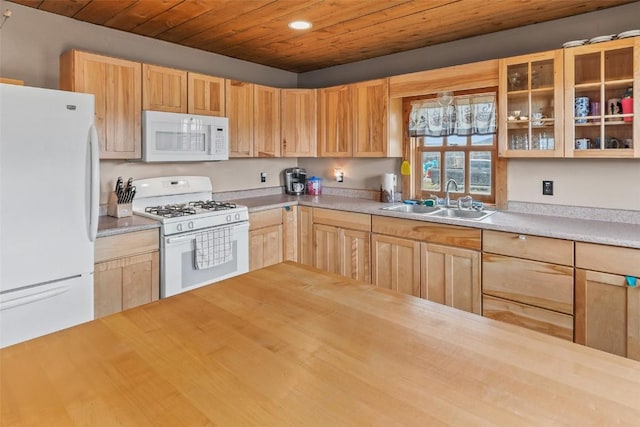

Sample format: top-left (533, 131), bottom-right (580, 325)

top-left (234, 194), bottom-right (640, 249)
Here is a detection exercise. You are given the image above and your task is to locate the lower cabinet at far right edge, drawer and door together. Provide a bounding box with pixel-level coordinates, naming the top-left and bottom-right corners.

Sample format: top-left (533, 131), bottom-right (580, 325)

top-left (575, 242), bottom-right (640, 360)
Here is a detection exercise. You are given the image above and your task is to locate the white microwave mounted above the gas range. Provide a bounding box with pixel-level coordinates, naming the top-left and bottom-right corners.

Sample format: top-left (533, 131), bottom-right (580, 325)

top-left (142, 110), bottom-right (229, 162)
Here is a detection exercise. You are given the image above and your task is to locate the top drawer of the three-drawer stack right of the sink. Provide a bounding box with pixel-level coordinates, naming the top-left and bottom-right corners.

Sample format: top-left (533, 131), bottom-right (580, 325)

top-left (482, 230), bottom-right (573, 266)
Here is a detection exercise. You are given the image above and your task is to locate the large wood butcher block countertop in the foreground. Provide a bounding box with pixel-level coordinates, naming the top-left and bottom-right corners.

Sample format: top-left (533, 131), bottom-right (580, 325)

top-left (0, 263), bottom-right (640, 427)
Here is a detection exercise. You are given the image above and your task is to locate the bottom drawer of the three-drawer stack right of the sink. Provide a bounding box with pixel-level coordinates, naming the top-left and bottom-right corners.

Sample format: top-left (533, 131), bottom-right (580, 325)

top-left (482, 295), bottom-right (573, 341)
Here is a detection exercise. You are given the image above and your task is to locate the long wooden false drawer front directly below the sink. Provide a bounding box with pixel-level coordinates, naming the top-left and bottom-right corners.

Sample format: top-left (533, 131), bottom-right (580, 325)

top-left (371, 215), bottom-right (482, 250)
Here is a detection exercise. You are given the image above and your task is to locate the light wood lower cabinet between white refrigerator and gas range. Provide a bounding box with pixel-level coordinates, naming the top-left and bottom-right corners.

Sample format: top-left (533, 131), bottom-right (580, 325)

top-left (93, 229), bottom-right (160, 319)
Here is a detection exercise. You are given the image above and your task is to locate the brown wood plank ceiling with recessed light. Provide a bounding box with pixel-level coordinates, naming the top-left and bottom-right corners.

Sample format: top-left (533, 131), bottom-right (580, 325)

top-left (7, 0), bottom-right (636, 73)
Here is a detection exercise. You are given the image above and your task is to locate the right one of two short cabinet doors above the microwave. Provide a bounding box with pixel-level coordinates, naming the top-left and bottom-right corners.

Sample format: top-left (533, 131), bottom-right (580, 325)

top-left (187, 72), bottom-right (225, 117)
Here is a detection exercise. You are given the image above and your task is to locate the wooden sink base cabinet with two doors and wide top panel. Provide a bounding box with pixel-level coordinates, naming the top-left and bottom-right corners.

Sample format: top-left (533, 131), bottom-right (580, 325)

top-left (371, 215), bottom-right (481, 314)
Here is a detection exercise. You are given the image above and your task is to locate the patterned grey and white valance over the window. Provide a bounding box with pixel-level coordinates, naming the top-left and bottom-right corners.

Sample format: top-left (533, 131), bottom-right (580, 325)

top-left (409, 93), bottom-right (497, 136)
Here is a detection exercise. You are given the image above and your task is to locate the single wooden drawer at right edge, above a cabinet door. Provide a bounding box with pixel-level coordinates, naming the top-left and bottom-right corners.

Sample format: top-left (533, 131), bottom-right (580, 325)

top-left (576, 242), bottom-right (640, 277)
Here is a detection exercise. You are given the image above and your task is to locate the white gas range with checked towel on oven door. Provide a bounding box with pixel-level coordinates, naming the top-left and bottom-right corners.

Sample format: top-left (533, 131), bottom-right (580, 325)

top-left (133, 176), bottom-right (249, 298)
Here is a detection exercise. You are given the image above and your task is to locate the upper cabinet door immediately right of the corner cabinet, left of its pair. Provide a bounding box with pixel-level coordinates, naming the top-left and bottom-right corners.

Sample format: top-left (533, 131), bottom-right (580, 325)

top-left (318, 85), bottom-right (353, 157)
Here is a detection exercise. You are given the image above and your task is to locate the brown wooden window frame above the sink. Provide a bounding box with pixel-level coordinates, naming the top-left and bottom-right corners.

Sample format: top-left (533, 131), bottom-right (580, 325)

top-left (402, 87), bottom-right (506, 205)
